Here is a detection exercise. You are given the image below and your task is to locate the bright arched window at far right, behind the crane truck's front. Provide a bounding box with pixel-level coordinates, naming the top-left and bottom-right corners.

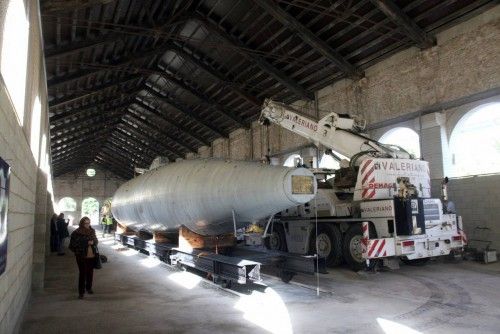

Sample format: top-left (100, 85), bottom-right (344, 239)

top-left (450, 103), bottom-right (500, 176)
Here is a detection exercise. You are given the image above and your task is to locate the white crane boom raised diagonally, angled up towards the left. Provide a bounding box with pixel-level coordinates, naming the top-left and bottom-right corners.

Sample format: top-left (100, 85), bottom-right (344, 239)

top-left (260, 99), bottom-right (412, 159)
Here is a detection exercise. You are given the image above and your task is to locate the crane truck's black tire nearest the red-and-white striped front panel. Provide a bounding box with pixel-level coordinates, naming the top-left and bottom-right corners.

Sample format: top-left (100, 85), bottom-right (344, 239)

top-left (342, 224), bottom-right (377, 271)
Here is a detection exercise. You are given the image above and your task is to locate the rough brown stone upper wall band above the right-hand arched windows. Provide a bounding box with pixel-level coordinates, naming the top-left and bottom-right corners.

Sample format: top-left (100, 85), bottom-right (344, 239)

top-left (318, 6), bottom-right (500, 123)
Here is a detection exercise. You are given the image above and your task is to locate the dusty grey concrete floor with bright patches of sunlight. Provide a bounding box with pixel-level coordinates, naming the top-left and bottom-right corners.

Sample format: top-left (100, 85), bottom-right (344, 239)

top-left (21, 238), bottom-right (500, 334)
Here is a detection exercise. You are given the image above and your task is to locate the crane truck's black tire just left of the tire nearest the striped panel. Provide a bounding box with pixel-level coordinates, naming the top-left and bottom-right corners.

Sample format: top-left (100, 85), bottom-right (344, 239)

top-left (309, 225), bottom-right (342, 267)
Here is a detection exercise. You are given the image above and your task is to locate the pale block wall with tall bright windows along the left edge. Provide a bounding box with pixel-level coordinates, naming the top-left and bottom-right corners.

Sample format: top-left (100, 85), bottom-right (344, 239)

top-left (0, 0), bottom-right (53, 333)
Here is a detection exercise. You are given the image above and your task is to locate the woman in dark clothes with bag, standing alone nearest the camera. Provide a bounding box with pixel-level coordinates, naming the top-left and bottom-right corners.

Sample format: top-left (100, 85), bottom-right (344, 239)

top-left (69, 217), bottom-right (98, 299)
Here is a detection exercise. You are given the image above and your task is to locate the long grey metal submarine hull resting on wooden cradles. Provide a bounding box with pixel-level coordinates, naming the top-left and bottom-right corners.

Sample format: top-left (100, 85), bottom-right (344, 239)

top-left (112, 159), bottom-right (317, 235)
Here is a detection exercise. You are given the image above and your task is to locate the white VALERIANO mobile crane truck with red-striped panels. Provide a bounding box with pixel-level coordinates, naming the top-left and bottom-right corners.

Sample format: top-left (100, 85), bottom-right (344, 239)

top-left (259, 99), bottom-right (466, 270)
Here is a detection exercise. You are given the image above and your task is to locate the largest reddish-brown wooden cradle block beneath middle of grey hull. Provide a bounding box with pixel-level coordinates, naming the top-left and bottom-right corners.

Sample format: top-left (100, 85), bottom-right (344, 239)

top-left (179, 226), bottom-right (236, 250)
